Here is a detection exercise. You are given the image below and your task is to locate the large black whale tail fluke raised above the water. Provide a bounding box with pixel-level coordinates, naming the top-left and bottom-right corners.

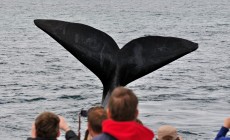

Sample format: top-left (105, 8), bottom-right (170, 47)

top-left (34, 19), bottom-right (198, 106)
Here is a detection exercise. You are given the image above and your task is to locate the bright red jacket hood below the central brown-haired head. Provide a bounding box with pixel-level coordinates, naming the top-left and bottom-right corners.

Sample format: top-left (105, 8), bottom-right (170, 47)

top-left (102, 119), bottom-right (154, 140)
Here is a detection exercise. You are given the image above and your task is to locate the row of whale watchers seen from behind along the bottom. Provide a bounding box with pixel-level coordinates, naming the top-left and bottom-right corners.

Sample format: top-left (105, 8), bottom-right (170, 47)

top-left (27, 87), bottom-right (230, 140)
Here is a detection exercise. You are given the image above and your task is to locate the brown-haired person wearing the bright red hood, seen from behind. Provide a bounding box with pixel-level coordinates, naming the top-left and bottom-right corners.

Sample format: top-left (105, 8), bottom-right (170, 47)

top-left (93, 87), bottom-right (154, 140)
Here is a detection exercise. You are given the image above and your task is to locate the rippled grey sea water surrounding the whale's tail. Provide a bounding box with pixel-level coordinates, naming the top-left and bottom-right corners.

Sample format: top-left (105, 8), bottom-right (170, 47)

top-left (0, 0), bottom-right (230, 140)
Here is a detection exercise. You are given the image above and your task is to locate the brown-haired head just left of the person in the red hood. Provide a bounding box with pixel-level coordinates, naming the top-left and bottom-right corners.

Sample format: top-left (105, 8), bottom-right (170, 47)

top-left (88, 107), bottom-right (107, 137)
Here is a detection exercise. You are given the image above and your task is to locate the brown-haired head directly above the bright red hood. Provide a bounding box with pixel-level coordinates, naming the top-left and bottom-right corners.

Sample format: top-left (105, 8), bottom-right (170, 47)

top-left (107, 87), bottom-right (138, 121)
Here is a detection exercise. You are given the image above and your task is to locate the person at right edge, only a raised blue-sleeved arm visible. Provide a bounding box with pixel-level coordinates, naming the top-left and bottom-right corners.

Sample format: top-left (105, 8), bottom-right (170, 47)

top-left (215, 117), bottom-right (230, 140)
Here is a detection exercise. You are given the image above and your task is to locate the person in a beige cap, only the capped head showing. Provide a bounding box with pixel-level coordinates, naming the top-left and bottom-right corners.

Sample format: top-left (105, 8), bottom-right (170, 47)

top-left (157, 125), bottom-right (182, 140)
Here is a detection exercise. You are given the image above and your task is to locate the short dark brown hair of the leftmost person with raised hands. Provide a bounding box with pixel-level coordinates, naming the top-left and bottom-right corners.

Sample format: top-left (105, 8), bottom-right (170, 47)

top-left (35, 112), bottom-right (60, 138)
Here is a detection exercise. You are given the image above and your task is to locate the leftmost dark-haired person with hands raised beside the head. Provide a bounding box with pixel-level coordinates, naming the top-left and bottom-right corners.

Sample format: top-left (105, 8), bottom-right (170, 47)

top-left (27, 112), bottom-right (79, 140)
